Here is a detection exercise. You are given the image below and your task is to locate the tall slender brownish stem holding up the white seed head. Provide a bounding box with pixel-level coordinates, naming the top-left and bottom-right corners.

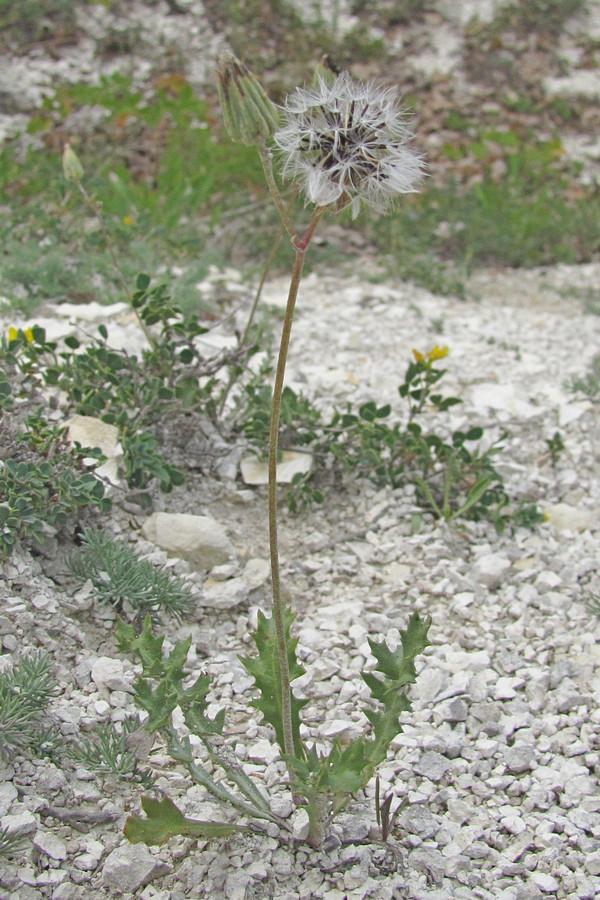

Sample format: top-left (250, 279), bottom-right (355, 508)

top-left (269, 207), bottom-right (324, 757)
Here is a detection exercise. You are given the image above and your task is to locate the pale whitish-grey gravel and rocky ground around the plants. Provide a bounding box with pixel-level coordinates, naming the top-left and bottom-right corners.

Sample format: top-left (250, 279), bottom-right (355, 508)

top-left (0, 2), bottom-right (600, 900)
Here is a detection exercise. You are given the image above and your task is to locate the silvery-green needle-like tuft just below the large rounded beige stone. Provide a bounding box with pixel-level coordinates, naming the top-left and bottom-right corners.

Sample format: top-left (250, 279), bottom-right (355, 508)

top-left (69, 528), bottom-right (194, 621)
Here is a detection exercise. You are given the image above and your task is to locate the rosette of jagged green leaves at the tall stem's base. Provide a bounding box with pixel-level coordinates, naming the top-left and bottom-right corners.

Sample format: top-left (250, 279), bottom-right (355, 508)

top-left (117, 608), bottom-right (430, 846)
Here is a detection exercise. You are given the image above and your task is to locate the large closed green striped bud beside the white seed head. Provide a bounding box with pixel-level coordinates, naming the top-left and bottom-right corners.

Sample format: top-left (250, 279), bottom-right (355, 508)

top-left (217, 53), bottom-right (279, 146)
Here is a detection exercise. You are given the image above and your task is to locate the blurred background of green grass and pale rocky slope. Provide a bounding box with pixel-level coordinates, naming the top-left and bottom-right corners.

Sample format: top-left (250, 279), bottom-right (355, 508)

top-left (0, 0), bottom-right (600, 316)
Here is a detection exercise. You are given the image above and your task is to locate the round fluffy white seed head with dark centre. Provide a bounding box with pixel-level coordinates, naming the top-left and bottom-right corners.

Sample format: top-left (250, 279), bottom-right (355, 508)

top-left (274, 72), bottom-right (424, 216)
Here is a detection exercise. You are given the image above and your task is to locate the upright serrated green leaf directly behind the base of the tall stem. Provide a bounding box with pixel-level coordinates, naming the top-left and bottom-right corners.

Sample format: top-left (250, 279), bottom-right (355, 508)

top-left (240, 607), bottom-right (308, 759)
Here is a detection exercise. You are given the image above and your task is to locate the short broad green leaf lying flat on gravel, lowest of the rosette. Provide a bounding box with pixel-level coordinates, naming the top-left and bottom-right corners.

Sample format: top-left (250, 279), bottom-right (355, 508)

top-left (123, 797), bottom-right (250, 846)
